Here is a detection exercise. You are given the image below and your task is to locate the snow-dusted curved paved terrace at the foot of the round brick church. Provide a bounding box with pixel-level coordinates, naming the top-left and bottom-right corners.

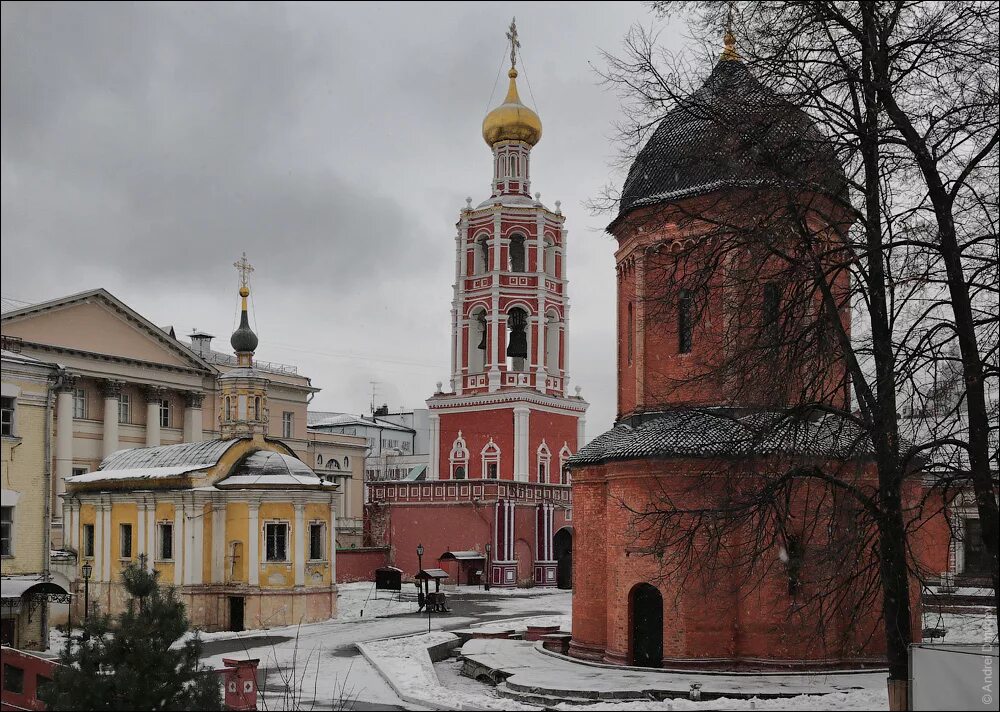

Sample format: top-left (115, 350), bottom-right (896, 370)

top-left (462, 639), bottom-right (886, 704)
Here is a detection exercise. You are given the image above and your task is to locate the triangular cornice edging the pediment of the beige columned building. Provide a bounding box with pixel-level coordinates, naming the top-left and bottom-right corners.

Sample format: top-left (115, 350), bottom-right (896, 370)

top-left (2, 288), bottom-right (218, 373)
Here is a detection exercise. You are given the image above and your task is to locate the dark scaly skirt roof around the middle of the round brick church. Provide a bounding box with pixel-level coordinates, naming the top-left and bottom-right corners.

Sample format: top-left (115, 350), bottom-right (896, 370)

top-left (567, 408), bottom-right (872, 467)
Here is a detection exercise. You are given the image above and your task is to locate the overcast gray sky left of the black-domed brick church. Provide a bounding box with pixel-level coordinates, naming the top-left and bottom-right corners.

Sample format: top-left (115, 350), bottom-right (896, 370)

top-left (2, 2), bottom-right (677, 437)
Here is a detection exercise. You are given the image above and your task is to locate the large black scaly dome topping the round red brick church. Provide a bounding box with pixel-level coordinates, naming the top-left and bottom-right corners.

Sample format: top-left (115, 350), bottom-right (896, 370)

top-left (619, 60), bottom-right (845, 215)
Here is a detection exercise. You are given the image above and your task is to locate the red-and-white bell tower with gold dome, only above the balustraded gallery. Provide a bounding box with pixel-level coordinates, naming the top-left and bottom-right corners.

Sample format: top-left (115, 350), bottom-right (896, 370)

top-left (428, 22), bottom-right (586, 481)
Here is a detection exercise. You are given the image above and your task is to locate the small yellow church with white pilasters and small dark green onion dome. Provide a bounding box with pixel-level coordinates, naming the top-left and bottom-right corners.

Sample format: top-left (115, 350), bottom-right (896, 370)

top-left (63, 260), bottom-right (339, 631)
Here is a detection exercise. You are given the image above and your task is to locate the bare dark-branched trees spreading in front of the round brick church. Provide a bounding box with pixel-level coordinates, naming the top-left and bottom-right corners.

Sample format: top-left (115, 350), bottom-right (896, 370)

top-left (588, 2), bottom-right (1000, 700)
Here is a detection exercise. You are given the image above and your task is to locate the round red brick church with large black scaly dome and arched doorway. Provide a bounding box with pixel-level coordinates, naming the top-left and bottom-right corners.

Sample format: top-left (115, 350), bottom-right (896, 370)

top-left (569, 33), bottom-right (919, 669)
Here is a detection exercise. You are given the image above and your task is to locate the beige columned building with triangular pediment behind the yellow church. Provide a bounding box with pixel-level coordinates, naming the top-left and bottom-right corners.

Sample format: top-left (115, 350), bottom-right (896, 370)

top-left (2, 289), bottom-right (366, 561)
